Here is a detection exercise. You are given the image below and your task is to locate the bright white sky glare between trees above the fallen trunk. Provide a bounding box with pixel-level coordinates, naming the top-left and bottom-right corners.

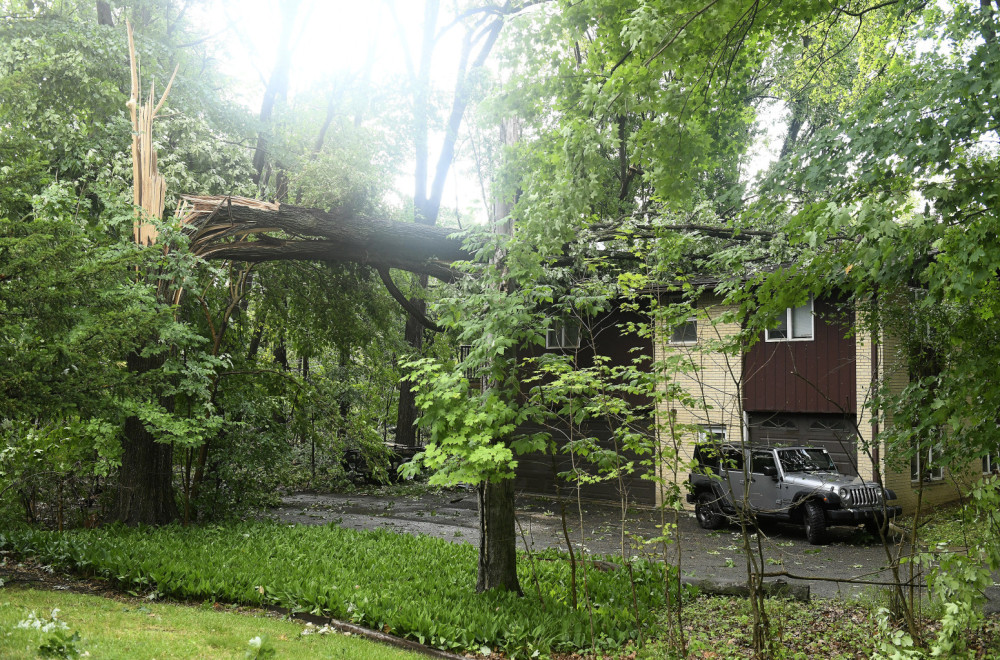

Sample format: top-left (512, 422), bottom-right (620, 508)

top-left (194, 0), bottom-right (485, 222)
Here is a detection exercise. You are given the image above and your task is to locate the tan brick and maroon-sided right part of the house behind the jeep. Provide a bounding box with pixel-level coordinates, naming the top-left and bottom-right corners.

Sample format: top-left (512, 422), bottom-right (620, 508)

top-left (655, 293), bottom-right (976, 512)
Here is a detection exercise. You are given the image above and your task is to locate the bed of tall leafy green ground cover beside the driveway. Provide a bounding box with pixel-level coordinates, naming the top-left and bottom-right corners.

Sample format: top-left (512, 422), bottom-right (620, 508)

top-left (0, 522), bottom-right (665, 657)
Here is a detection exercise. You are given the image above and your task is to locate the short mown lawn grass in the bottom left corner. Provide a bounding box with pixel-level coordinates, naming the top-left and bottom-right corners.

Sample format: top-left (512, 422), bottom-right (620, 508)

top-left (0, 587), bottom-right (420, 660)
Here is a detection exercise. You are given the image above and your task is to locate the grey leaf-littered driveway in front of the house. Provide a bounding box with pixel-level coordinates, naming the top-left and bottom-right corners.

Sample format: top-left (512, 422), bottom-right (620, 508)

top-left (271, 490), bottom-right (916, 598)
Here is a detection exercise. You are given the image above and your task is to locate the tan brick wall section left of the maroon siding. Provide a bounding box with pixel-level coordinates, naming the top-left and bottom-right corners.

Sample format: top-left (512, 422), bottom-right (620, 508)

top-left (653, 297), bottom-right (743, 506)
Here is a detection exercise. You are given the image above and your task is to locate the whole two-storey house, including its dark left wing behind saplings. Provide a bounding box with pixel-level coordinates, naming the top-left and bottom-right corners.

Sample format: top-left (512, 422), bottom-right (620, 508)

top-left (516, 289), bottom-right (988, 511)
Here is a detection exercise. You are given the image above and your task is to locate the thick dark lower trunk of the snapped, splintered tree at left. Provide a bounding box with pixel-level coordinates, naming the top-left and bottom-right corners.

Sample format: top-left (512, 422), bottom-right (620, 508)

top-left (112, 353), bottom-right (178, 525)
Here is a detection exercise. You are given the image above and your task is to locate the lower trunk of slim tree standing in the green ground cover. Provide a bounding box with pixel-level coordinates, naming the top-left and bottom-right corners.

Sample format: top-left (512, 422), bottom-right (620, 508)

top-left (476, 479), bottom-right (524, 596)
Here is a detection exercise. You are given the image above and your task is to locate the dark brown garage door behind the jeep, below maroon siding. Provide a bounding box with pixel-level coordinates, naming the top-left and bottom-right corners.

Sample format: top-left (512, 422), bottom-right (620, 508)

top-left (748, 412), bottom-right (858, 475)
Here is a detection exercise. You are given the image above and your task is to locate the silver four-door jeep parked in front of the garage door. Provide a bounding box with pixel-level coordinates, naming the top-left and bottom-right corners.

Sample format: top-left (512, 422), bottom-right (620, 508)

top-left (687, 443), bottom-right (902, 544)
